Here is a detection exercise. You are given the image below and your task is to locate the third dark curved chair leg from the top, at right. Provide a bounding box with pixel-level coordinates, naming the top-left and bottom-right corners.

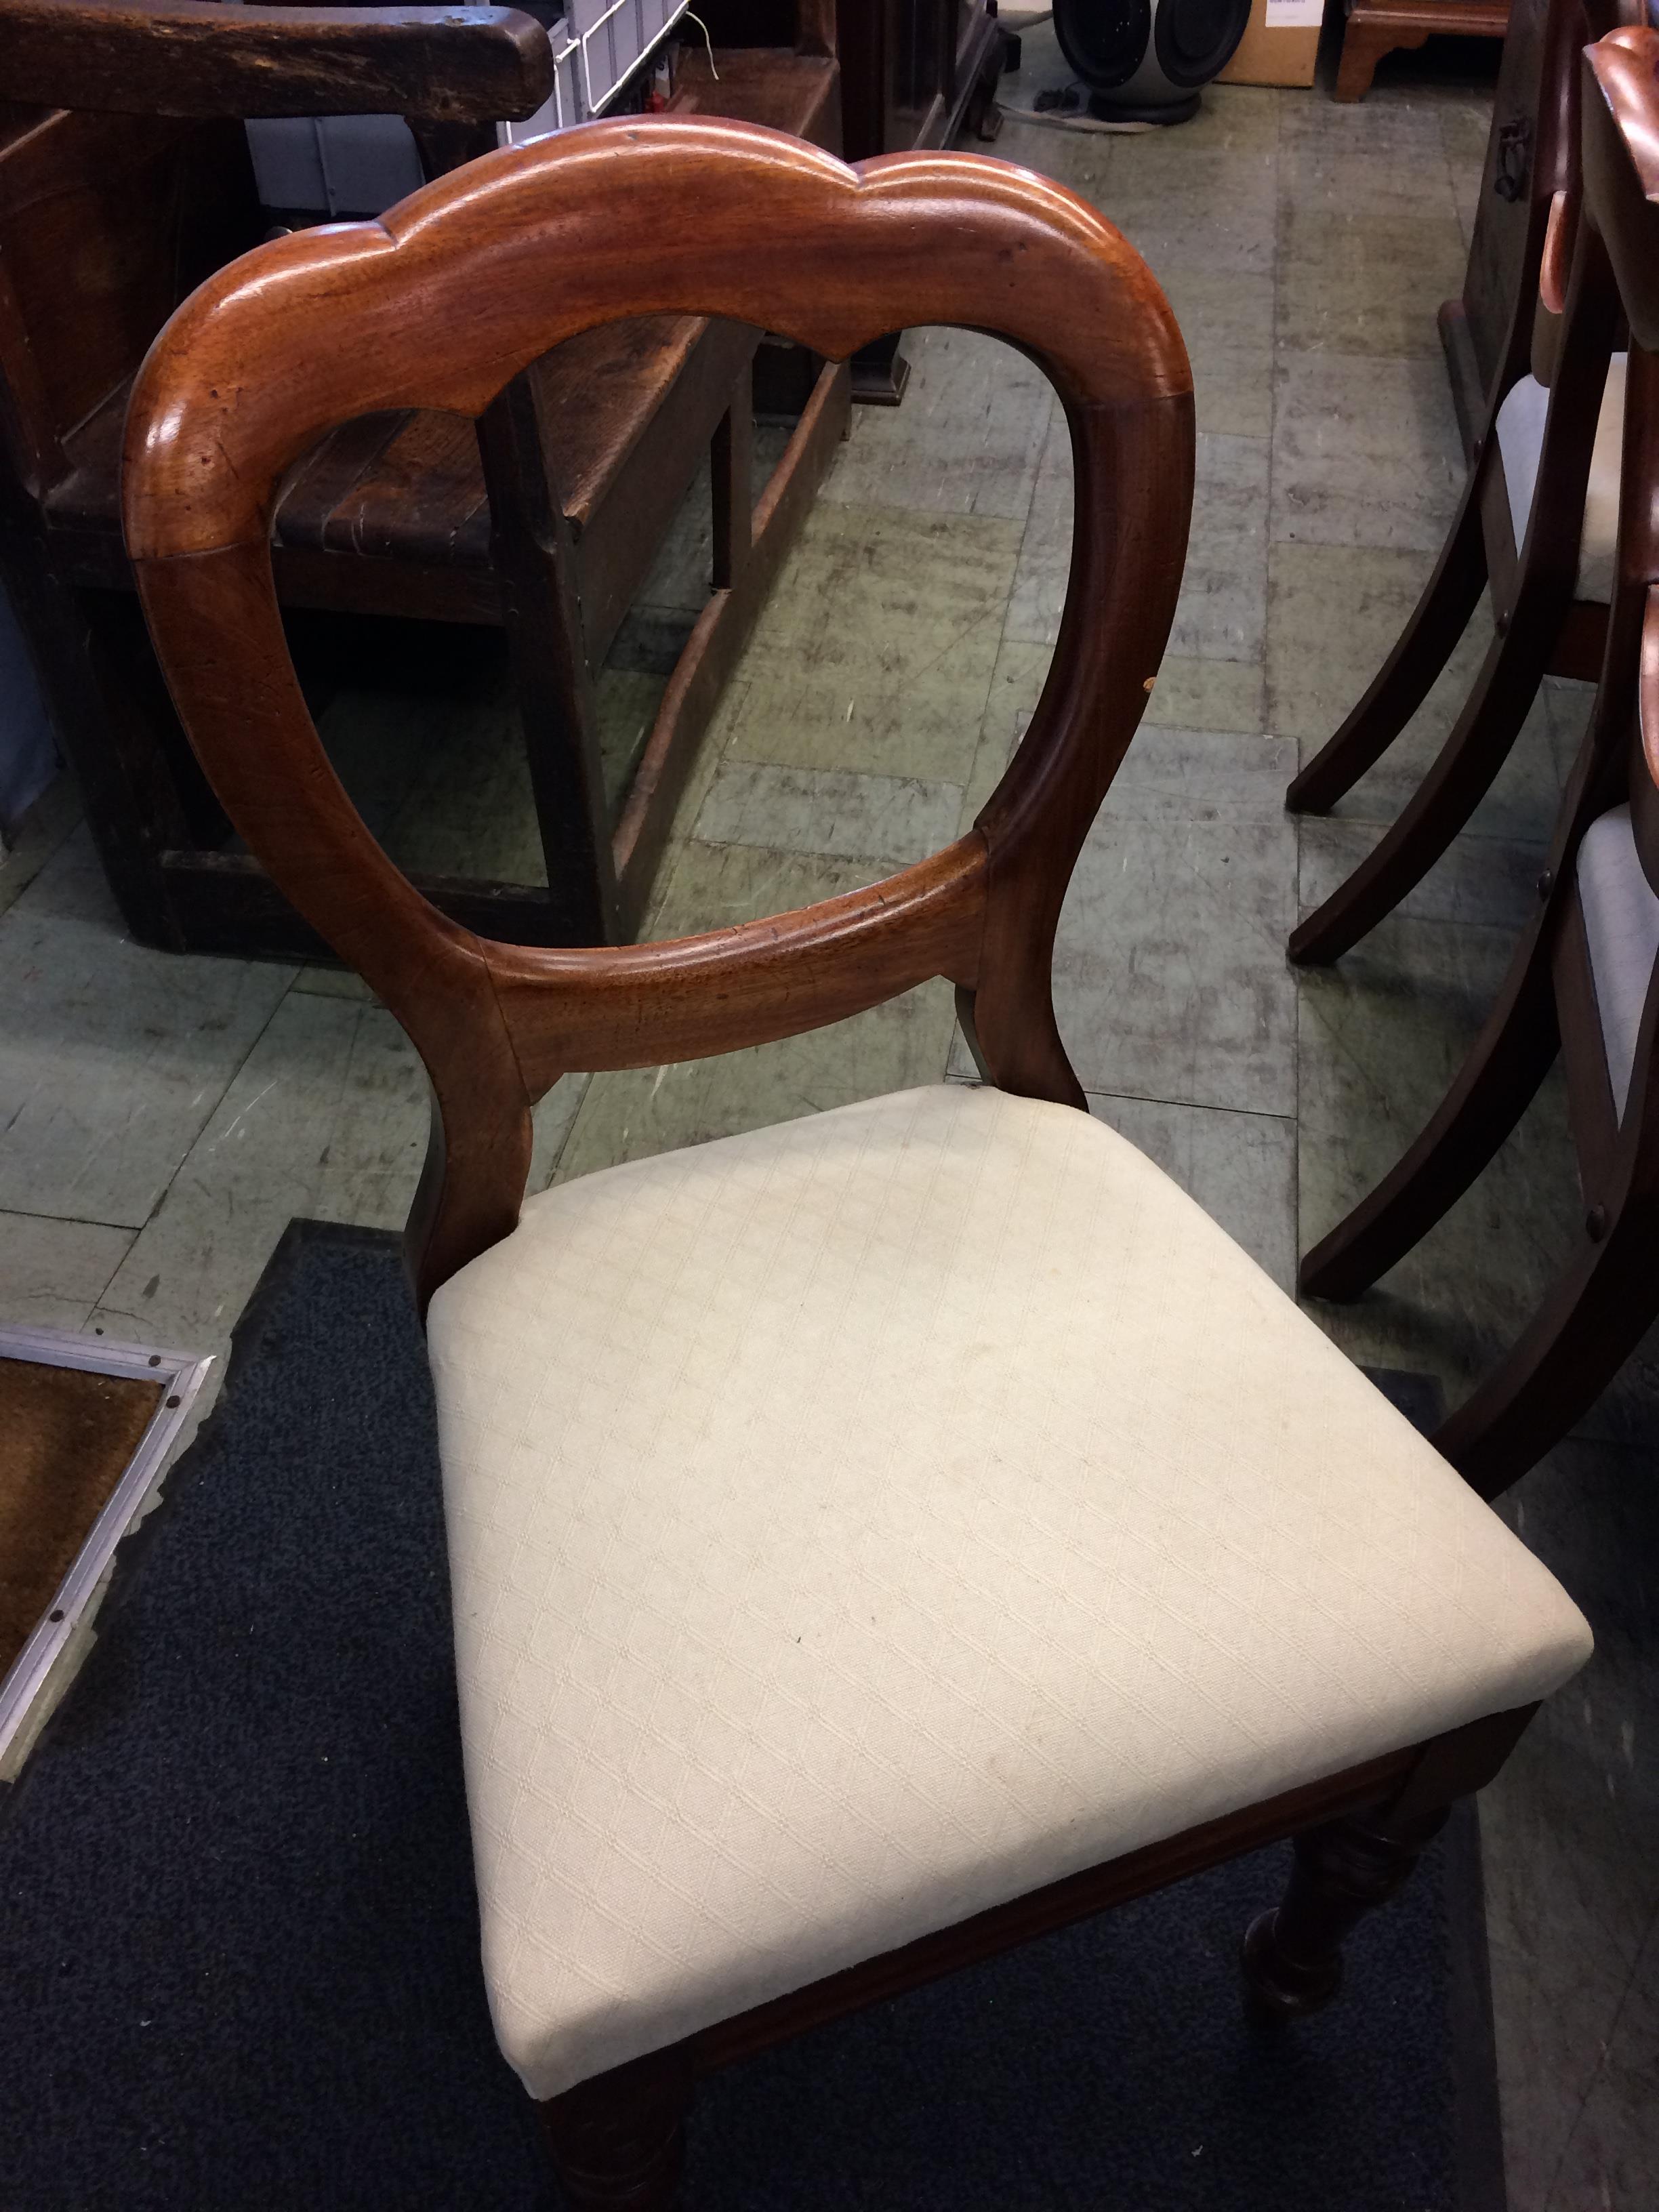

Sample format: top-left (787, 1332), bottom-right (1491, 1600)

top-left (1296, 914), bottom-right (1559, 1303)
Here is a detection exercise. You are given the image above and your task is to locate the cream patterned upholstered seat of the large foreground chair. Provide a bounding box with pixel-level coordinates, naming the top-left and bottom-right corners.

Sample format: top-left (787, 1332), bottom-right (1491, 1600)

top-left (429, 1084), bottom-right (1589, 2097)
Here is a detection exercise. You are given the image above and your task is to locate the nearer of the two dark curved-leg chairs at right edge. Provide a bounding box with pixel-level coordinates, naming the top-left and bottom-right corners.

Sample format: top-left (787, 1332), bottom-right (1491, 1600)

top-left (1300, 28), bottom-right (1659, 1498)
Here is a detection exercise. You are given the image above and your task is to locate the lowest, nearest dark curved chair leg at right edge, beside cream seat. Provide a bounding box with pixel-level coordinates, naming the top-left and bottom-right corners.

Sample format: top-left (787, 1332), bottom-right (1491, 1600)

top-left (1431, 1208), bottom-right (1659, 1498)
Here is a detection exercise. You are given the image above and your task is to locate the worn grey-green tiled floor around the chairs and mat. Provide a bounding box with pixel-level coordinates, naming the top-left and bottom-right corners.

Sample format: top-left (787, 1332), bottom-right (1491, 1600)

top-left (0, 35), bottom-right (1659, 2212)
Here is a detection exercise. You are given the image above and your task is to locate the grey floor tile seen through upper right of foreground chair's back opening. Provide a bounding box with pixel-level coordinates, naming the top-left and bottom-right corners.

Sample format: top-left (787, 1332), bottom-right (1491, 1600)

top-left (821, 329), bottom-right (1053, 522)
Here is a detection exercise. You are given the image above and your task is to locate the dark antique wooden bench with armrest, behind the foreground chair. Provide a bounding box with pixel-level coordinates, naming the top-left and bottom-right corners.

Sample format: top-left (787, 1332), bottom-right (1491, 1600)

top-left (0, 0), bottom-right (847, 958)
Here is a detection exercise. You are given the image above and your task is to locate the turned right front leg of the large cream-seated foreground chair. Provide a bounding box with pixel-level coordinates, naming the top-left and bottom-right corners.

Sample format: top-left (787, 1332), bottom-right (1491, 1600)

top-left (1243, 1807), bottom-right (1447, 2020)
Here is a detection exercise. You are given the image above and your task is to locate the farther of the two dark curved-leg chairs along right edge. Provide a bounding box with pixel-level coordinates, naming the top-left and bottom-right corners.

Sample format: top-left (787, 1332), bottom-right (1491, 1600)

top-left (1285, 0), bottom-right (1624, 966)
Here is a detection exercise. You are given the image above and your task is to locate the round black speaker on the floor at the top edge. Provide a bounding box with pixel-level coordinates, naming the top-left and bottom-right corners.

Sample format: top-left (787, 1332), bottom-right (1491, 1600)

top-left (1055, 0), bottom-right (1250, 124)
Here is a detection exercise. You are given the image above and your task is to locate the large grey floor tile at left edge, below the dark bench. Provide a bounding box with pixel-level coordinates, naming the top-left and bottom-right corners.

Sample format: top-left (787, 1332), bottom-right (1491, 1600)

top-left (0, 830), bottom-right (294, 1228)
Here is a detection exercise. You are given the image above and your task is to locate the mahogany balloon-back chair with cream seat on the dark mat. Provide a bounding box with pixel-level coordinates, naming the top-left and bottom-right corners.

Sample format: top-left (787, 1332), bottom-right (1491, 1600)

top-left (124, 122), bottom-right (1589, 2212)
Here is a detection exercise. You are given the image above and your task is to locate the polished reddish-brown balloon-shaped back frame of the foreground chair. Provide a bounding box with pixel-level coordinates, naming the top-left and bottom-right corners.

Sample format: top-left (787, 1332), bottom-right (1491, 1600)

top-left (124, 119), bottom-right (1192, 1300)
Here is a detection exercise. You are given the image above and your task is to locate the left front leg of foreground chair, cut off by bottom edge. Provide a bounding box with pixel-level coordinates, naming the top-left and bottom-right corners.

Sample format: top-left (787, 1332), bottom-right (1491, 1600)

top-left (537, 2046), bottom-right (695, 2212)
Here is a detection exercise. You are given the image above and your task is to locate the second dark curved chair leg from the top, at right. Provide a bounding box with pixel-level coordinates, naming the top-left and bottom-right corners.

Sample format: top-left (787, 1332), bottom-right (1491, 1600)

top-left (1290, 609), bottom-right (1566, 966)
